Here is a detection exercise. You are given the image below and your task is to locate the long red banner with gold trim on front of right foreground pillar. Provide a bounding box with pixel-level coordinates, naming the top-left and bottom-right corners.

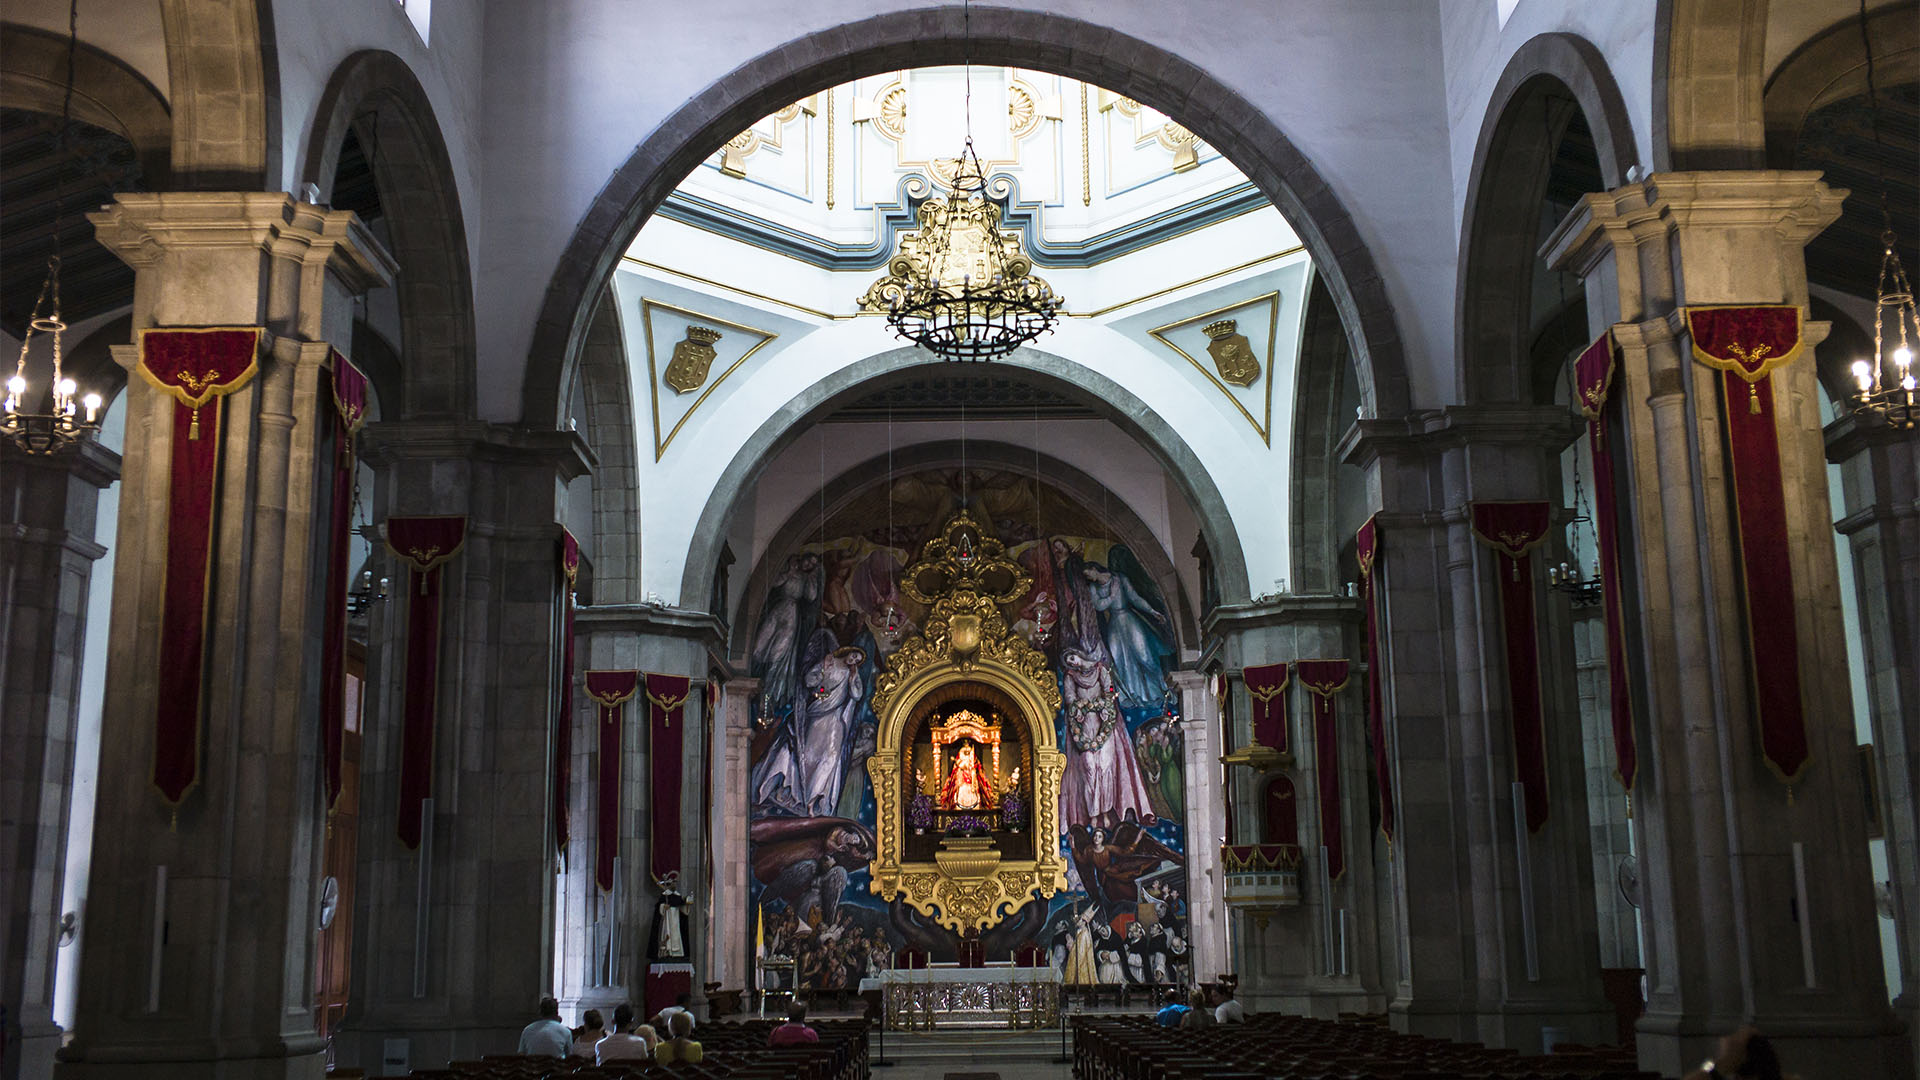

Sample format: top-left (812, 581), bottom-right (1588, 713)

top-left (1686, 306), bottom-right (1809, 784)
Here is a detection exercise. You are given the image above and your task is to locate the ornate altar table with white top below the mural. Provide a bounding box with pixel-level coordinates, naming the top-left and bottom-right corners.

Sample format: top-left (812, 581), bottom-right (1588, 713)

top-left (860, 965), bottom-right (1060, 1032)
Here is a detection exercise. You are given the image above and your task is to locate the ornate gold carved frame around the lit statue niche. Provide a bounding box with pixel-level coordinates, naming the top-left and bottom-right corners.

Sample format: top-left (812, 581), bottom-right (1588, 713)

top-left (868, 511), bottom-right (1066, 930)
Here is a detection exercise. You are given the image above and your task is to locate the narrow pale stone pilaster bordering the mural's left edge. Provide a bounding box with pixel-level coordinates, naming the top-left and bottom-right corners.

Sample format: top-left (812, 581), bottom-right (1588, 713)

top-left (707, 678), bottom-right (760, 990)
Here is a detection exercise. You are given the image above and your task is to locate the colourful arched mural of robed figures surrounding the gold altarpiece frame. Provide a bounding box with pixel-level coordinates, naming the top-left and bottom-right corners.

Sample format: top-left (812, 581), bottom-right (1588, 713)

top-left (749, 469), bottom-right (1190, 990)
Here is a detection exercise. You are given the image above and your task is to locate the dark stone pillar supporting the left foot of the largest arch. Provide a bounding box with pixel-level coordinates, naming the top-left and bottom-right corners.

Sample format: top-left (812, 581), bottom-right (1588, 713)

top-left (334, 421), bottom-right (591, 1070)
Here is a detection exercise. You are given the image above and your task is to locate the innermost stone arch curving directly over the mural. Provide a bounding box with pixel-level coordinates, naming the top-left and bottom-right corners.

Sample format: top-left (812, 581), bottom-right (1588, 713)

top-left (730, 440), bottom-right (1200, 653)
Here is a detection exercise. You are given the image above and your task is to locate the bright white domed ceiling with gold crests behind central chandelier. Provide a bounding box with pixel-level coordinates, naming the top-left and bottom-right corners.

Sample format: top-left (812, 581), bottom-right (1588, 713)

top-left (614, 67), bottom-right (1313, 600)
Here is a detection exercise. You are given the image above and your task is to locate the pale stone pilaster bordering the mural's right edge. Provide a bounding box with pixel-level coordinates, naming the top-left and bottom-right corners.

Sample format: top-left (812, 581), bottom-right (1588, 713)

top-left (1173, 671), bottom-right (1233, 982)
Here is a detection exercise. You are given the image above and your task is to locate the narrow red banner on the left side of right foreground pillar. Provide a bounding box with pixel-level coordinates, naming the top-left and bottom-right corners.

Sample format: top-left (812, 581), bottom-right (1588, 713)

top-left (1572, 331), bottom-right (1640, 794)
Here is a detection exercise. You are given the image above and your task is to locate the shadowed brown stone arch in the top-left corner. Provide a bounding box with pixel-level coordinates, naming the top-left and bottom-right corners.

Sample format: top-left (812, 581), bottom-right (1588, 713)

top-left (0, 23), bottom-right (173, 190)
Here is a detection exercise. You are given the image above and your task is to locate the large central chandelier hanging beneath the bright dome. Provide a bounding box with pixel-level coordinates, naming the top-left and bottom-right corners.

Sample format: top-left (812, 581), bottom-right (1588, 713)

top-left (877, 6), bottom-right (1060, 361)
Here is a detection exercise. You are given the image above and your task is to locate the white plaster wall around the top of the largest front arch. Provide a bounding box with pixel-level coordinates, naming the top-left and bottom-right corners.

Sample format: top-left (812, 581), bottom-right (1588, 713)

top-left (472, 0), bottom-right (1459, 418)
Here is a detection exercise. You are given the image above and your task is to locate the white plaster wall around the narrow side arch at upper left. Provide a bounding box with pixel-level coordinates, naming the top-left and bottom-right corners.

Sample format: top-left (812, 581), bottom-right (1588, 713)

top-left (273, 0), bottom-right (487, 255)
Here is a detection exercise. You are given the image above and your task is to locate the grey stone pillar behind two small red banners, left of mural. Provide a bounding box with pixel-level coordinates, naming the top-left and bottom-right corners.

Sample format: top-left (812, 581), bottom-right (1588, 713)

top-left (574, 603), bottom-right (721, 1013)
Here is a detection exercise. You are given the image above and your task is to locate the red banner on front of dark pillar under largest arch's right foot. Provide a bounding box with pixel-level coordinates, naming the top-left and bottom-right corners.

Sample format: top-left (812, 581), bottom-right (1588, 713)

top-left (1473, 502), bottom-right (1551, 832)
